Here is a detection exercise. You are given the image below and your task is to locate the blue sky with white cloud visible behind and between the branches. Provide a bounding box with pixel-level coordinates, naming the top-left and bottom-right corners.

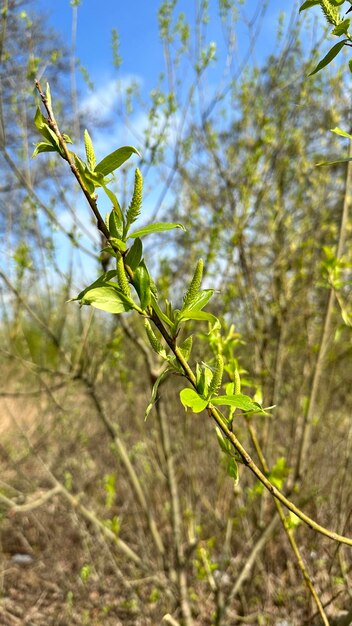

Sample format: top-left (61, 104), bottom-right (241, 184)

top-left (28, 0), bottom-right (314, 282)
